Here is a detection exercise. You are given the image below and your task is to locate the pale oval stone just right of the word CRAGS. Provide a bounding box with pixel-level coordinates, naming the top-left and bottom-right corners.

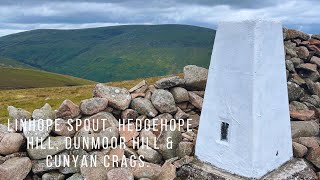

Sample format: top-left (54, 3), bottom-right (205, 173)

top-left (137, 144), bottom-right (162, 164)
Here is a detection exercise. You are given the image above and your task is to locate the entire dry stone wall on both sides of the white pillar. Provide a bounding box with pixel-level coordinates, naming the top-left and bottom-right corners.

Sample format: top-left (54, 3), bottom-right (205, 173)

top-left (0, 29), bottom-right (320, 180)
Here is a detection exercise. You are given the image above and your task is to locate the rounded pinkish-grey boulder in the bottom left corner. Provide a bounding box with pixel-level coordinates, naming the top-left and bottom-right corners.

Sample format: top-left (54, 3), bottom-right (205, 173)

top-left (0, 157), bottom-right (32, 180)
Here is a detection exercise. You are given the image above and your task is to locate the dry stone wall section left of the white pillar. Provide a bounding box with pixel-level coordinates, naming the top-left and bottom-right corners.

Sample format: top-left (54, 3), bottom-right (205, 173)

top-left (0, 65), bottom-right (208, 180)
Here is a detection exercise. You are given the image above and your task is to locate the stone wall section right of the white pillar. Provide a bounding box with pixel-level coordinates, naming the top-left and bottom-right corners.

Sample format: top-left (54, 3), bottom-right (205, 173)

top-left (284, 29), bottom-right (320, 177)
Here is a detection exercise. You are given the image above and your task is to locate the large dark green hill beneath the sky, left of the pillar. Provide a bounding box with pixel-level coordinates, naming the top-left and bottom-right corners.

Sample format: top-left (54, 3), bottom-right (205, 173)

top-left (0, 25), bottom-right (215, 82)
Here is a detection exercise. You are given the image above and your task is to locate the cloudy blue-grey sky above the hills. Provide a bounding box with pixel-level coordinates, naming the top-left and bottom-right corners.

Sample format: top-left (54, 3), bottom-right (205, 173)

top-left (0, 0), bottom-right (320, 36)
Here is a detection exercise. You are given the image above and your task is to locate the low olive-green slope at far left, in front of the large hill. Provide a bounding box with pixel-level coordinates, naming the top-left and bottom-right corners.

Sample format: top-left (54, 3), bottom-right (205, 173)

top-left (0, 67), bottom-right (95, 90)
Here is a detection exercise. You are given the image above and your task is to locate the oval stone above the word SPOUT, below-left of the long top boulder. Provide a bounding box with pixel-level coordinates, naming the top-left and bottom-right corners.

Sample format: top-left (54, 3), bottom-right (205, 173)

top-left (80, 98), bottom-right (108, 115)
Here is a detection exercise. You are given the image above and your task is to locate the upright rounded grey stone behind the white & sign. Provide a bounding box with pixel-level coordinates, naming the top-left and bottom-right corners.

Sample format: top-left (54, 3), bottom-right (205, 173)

top-left (157, 125), bottom-right (182, 160)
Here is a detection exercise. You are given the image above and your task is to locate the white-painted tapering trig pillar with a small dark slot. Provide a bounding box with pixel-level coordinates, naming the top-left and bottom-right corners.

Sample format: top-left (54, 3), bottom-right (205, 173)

top-left (195, 20), bottom-right (292, 178)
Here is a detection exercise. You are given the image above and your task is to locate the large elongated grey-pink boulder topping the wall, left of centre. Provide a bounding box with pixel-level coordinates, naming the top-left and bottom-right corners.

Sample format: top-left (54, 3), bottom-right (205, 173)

top-left (93, 84), bottom-right (131, 110)
